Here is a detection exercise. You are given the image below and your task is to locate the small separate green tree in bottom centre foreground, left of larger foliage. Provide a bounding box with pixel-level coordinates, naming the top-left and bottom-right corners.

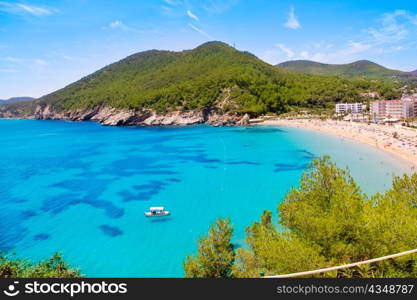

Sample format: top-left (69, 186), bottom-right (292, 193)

top-left (184, 219), bottom-right (235, 278)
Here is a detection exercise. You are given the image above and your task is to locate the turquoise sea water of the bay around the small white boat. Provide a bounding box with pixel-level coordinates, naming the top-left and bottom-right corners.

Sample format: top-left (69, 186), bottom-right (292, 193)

top-left (0, 120), bottom-right (409, 277)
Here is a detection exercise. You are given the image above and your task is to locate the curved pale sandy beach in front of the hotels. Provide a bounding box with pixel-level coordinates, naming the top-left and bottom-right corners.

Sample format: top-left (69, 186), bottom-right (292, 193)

top-left (257, 119), bottom-right (417, 171)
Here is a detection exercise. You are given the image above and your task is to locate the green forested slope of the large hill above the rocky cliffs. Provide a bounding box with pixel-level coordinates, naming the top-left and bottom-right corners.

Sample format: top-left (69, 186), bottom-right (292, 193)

top-left (39, 42), bottom-right (397, 115)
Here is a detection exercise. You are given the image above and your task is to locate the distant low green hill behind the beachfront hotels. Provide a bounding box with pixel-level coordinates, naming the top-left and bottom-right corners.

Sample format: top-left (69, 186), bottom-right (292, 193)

top-left (278, 60), bottom-right (412, 79)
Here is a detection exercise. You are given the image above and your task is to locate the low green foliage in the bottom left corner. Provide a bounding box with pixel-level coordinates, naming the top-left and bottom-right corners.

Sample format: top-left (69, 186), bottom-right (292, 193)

top-left (0, 254), bottom-right (81, 278)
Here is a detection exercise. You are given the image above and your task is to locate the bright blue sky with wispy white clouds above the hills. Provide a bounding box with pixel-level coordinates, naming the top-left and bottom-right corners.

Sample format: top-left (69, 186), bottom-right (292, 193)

top-left (0, 0), bottom-right (417, 98)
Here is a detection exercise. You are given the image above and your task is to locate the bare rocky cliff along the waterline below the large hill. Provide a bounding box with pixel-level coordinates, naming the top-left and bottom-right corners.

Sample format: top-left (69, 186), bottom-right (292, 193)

top-left (27, 105), bottom-right (249, 126)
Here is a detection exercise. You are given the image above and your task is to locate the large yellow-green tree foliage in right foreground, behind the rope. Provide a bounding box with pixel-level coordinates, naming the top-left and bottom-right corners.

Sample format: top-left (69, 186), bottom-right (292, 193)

top-left (184, 157), bottom-right (417, 277)
